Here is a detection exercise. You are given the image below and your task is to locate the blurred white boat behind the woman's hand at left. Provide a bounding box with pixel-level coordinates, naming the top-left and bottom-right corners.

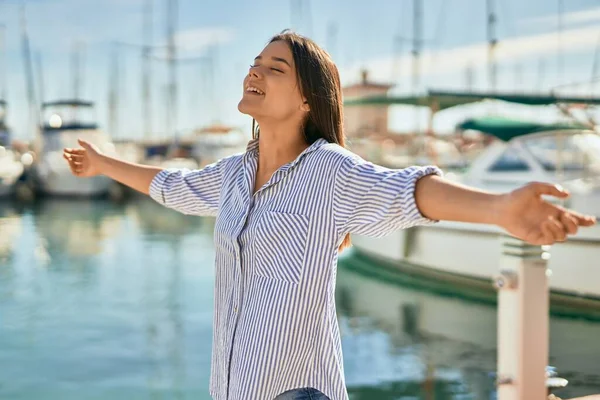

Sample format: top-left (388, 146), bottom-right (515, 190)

top-left (34, 100), bottom-right (115, 196)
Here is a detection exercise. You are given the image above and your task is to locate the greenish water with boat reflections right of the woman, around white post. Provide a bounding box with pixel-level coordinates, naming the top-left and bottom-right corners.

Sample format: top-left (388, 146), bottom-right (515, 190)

top-left (336, 257), bottom-right (600, 399)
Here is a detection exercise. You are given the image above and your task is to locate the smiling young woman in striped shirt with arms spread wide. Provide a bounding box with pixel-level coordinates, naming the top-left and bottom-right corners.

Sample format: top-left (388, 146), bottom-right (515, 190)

top-left (64, 32), bottom-right (595, 400)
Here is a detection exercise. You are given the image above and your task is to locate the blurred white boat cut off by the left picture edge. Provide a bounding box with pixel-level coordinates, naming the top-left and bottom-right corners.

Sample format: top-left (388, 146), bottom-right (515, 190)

top-left (0, 100), bottom-right (25, 198)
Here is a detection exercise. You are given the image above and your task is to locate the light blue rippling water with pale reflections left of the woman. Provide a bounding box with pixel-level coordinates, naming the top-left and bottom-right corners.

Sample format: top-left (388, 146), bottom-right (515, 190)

top-left (0, 199), bottom-right (214, 399)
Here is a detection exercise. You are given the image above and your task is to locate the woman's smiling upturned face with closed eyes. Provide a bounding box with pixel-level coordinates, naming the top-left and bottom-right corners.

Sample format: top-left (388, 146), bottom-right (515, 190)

top-left (238, 41), bottom-right (308, 124)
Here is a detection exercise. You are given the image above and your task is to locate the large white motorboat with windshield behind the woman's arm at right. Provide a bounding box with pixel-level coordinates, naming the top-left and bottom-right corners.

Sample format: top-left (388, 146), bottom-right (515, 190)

top-left (352, 125), bottom-right (600, 299)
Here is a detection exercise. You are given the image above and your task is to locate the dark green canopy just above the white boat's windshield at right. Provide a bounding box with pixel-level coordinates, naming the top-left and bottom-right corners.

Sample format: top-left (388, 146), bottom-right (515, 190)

top-left (456, 117), bottom-right (589, 142)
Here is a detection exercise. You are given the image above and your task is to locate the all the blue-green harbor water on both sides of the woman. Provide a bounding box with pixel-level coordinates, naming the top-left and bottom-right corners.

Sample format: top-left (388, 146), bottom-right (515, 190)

top-left (0, 197), bottom-right (600, 400)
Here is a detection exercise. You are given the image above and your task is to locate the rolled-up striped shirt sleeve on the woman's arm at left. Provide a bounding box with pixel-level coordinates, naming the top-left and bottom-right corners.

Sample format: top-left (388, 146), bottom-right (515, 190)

top-left (149, 159), bottom-right (225, 216)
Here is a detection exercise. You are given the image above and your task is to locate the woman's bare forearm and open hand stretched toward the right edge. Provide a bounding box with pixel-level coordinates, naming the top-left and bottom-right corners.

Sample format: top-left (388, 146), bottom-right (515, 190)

top-left (415, 175), bottom-right (596, 245)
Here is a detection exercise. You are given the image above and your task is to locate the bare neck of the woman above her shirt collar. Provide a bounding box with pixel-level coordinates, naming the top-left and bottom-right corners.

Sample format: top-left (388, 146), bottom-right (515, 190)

top-left (258, 118), bottom-right (309, 171)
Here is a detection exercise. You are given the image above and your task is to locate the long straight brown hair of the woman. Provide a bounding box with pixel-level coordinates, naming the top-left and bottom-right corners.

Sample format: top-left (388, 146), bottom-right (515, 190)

top-left (252, 29), bottom-right (350, 251)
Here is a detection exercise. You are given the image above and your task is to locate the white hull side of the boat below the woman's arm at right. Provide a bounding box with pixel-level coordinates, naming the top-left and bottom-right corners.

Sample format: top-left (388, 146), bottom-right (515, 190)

top-left (352, 222), bottom-right (600, 299)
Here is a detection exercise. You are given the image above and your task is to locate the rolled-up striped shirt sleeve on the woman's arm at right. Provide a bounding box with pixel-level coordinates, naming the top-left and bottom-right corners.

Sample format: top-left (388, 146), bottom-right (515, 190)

top-left (333, 157), bottom-right (443, 237)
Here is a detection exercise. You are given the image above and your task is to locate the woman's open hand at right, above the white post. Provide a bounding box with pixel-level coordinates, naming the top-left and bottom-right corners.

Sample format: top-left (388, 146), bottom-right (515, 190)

top-left (498, 182), bottom-right (596, 245)
